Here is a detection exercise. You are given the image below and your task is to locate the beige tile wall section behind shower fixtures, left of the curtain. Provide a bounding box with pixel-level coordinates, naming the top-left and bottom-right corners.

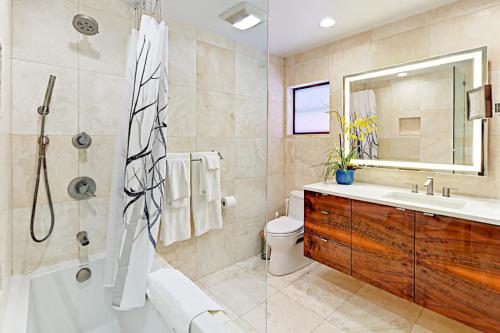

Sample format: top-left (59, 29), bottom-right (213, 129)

top-left (8, 0), bottom-right (133, 273)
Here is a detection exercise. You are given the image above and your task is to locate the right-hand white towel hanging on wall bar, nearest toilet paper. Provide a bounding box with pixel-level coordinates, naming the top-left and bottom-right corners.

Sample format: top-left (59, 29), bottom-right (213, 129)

top-left (191, 152), bottom-right (222, 236)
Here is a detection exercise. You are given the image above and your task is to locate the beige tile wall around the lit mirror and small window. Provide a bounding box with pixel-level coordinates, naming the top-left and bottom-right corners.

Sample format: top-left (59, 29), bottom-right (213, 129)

top-left (285, 0), bottom-right (500, 198)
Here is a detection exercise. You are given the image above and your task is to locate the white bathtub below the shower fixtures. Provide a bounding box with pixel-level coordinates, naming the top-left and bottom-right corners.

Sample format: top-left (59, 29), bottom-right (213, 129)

top-left (0, 256), bottom-right (226, 333)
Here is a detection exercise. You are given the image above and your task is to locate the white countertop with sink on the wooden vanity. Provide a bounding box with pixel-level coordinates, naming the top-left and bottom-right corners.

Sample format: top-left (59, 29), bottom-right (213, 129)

top-left (304, 182), bottom-right (500, 226)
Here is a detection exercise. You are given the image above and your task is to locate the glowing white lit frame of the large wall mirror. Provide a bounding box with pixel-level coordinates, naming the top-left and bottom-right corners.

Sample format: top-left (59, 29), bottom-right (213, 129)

top-left (343, 46), bottom-right (488, 176)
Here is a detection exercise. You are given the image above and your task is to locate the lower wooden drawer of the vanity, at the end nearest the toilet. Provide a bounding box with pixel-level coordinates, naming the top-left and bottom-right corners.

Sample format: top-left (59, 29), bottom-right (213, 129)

top-left (304, 232), bottom-right (351, 274)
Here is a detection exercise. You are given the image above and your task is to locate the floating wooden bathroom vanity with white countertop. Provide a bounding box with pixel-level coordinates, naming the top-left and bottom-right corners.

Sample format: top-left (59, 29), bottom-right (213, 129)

top-left (304, 183), bottom-right (500, 332)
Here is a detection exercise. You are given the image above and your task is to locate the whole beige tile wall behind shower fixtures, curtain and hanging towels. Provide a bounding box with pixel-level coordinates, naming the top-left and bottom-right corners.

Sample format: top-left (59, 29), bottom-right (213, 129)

top-left (9, 0), bottom-right (267, 279)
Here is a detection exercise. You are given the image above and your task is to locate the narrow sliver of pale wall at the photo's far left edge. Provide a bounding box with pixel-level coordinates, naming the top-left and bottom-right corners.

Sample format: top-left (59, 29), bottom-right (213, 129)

top-left (0, 1), bottom-right (12, 293)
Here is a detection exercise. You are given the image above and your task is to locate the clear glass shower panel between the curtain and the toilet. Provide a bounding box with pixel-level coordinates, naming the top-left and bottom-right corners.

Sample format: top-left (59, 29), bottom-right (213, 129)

top-left (153, 0), bottom-right (268, 331)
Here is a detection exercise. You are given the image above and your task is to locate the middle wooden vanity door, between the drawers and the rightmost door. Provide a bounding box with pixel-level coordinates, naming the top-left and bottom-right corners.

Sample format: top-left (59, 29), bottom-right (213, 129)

top-left (352, 200), bottom-right (415, 300)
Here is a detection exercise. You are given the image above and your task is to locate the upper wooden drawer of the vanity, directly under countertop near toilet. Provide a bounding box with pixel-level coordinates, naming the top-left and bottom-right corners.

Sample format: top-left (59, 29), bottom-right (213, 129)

top-left (304, 206), bottom-right (351, 246)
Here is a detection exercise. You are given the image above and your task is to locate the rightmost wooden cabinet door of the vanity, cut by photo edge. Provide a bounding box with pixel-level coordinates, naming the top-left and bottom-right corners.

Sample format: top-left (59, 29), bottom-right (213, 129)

top-left (415, 213), bottom-right (500, 332)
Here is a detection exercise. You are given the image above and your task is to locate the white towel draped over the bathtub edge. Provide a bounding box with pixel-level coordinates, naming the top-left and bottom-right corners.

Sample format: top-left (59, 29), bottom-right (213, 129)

top-left (147, 268), bottom-right (223, 333)
